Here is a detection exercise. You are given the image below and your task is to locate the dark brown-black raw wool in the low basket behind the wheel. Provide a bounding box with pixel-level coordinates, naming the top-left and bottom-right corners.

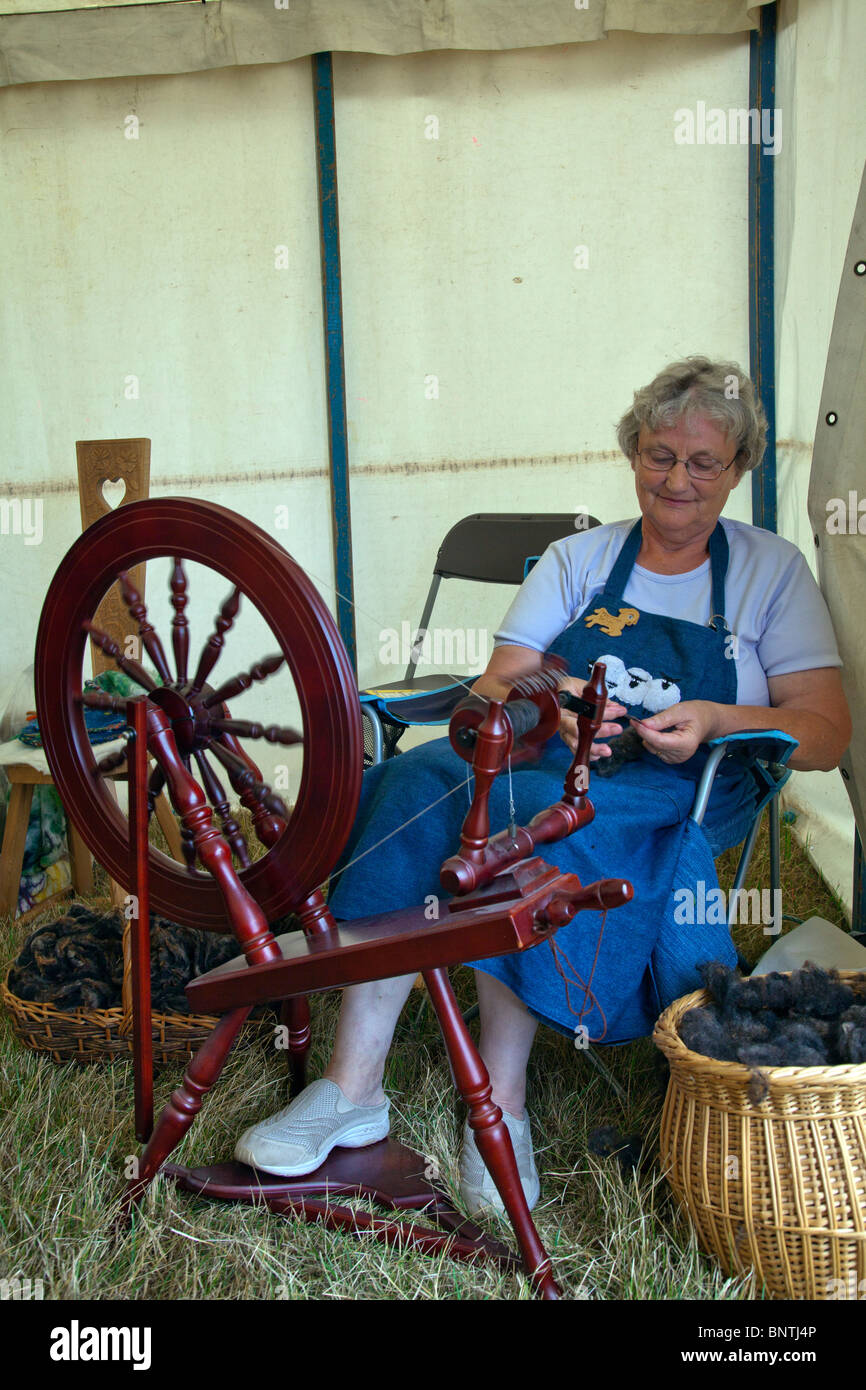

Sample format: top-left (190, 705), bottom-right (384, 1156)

top-left (8, 904), bottom-right (239, 1013)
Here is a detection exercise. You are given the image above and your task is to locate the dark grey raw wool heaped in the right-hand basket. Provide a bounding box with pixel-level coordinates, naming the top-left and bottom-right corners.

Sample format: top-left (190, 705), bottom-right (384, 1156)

top-left (680, 960), bottom-right (866, 1091)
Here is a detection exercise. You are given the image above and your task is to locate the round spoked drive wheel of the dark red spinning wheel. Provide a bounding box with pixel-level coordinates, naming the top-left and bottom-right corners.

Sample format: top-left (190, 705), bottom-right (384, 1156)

top-left (36, 498), bottom-right (363, 931)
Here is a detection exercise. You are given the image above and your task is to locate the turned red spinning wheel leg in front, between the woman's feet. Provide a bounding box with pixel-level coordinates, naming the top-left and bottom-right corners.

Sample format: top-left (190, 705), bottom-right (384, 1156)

top-left (424, 969), bottom-right (560, 1298)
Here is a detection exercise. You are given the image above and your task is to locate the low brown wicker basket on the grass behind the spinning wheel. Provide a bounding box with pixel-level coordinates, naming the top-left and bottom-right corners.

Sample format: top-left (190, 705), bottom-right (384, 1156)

top-left (0, 923), bottom-right (274, 1066)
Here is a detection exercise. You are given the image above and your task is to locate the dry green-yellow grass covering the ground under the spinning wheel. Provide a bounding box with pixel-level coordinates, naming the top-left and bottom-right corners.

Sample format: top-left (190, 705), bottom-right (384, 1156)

top-left (0, 811), bottom-right (844, 1300)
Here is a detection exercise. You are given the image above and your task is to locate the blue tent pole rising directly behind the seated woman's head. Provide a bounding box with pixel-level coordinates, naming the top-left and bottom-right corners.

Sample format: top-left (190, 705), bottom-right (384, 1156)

top-left (749, 4), bottom-right (777, 531)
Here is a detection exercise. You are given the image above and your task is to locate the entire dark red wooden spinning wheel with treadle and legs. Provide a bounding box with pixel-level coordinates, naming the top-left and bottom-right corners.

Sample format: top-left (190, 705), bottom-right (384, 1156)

top-left (36, 499), bottom-right (631, 1298)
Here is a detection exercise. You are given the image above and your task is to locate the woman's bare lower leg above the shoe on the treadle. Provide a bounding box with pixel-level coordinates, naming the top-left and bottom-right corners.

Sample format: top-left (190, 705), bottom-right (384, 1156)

top-left (322, 974), bottom-right (414, 1105)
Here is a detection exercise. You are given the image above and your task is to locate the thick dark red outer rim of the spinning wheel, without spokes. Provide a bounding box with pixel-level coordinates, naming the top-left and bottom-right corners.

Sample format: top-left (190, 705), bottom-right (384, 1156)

top-left (36, 498), bottom-right (363, 930)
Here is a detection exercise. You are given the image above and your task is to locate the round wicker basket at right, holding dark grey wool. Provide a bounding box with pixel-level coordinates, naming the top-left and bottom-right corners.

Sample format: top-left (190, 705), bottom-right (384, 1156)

top-left (653, 973), bottom-right (866, 1298)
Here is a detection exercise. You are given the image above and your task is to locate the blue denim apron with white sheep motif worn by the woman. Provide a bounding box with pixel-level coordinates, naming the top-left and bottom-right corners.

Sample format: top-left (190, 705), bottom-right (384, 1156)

top-left (329, 521), bottom-right (753, 1043)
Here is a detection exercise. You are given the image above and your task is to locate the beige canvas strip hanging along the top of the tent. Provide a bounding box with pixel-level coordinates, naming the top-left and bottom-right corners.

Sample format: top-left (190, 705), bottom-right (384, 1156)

top-left (0, 0), bottom-right (769, 86)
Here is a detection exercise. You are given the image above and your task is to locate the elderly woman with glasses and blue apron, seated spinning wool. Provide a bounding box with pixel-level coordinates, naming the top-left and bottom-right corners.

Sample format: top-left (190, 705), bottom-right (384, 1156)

top-left (236, 357), bottom-right (851, 1211)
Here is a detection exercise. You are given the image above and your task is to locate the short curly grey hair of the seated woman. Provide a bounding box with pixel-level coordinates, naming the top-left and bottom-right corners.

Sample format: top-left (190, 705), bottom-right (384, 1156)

top-left (617, 357), bottom-right (767, 474)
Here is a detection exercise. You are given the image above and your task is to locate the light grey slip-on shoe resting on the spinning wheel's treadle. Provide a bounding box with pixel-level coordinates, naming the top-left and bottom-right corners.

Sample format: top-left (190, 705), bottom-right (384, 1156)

top-left (235, 1077), bottom-right (391, 1177)
